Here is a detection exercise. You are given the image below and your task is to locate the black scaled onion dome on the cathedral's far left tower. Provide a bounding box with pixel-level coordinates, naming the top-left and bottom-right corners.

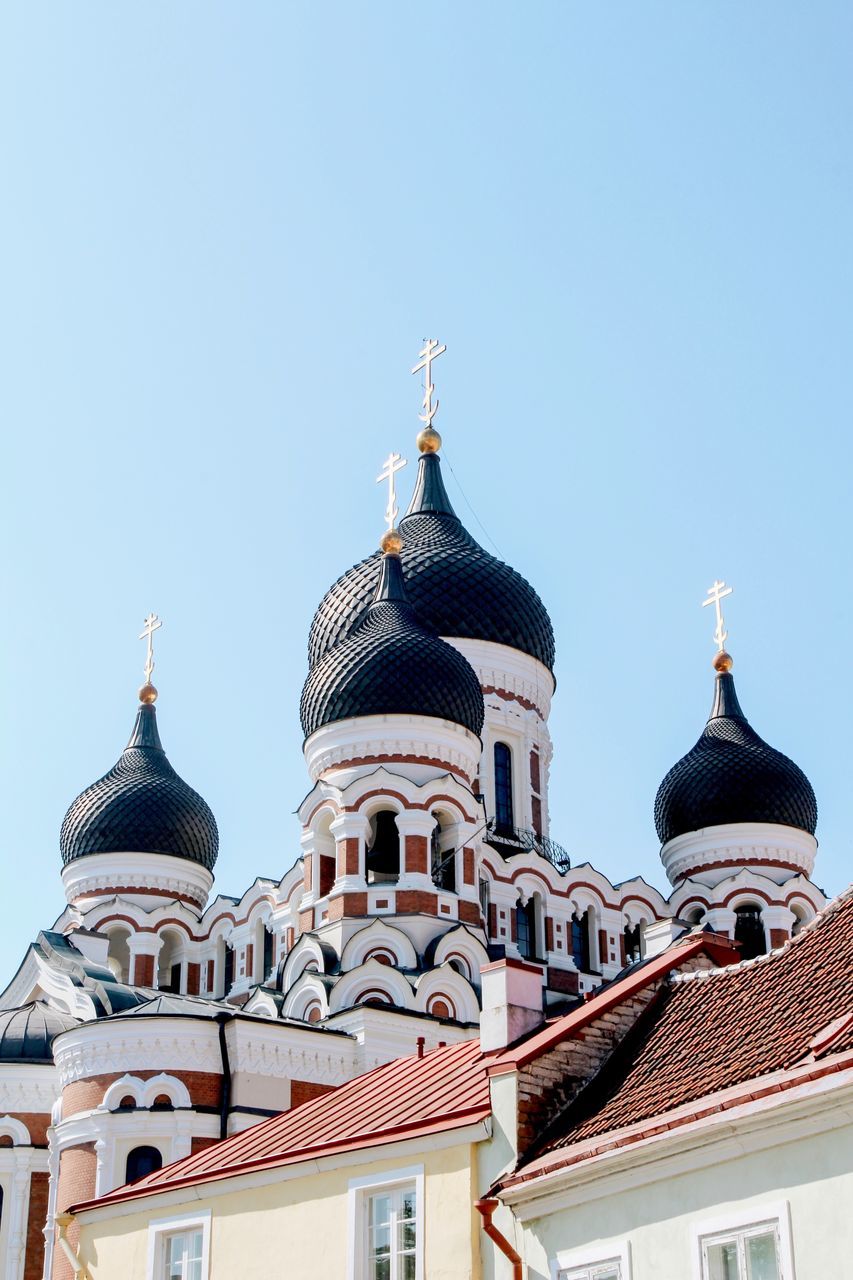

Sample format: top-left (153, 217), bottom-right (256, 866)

top-left (59, 703), bottom-right (219, 872)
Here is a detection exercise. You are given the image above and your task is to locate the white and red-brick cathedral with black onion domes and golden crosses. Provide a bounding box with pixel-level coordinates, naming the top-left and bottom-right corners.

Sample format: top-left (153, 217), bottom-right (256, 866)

top-left (0, 340), bottom-right (825, 1280)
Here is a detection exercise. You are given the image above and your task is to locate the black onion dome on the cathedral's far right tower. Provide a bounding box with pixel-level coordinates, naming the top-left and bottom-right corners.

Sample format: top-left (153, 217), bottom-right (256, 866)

top-left (654, 654), bottom-right (817, 845)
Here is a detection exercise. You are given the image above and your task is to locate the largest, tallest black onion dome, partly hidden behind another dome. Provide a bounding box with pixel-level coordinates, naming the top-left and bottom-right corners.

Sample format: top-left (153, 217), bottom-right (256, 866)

top-left (309, 453), bottom-right (555, 671)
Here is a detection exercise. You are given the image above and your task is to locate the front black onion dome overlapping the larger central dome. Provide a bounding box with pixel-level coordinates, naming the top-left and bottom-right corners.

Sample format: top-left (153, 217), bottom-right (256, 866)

top-left (300, 554), bottom-right (484, 737)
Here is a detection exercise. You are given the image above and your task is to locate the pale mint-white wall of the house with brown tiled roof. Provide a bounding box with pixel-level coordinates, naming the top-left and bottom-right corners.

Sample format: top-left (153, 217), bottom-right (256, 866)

top-left (514, 1111), bottom-right (853, 1280)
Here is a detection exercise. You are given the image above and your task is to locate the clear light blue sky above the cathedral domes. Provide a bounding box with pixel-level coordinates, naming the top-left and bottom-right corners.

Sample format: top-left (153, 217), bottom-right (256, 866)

top-left (0, 0), bottom-right (853, 974)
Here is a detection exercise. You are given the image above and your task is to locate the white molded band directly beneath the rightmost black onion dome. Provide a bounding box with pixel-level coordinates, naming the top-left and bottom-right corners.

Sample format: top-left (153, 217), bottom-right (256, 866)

top-left (661, 822), bottom-right (817, 886)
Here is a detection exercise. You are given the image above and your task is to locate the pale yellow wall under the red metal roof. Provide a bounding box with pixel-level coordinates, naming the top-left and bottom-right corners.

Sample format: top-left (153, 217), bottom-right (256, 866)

top-left (79, 1144), bottom-right (479, 1280)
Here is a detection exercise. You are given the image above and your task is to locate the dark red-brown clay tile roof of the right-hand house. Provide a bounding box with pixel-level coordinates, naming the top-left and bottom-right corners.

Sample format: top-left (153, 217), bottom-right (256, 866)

top-left (503, 886), bottom-right (853, 1185)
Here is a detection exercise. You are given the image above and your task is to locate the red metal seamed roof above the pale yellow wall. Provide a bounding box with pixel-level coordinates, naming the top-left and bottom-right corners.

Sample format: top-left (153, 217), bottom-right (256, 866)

top-left (73, 1039), bottom-right (491, 1212)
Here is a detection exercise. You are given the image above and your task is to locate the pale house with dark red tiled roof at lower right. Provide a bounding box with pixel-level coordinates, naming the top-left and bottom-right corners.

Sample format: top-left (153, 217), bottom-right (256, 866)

top-left (492, 890), bottom-right (853, 1280)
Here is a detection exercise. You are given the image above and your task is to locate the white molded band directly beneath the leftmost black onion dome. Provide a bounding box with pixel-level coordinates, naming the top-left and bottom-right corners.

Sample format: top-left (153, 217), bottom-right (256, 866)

top-left (61, 852), bottom-right (213, 911)
